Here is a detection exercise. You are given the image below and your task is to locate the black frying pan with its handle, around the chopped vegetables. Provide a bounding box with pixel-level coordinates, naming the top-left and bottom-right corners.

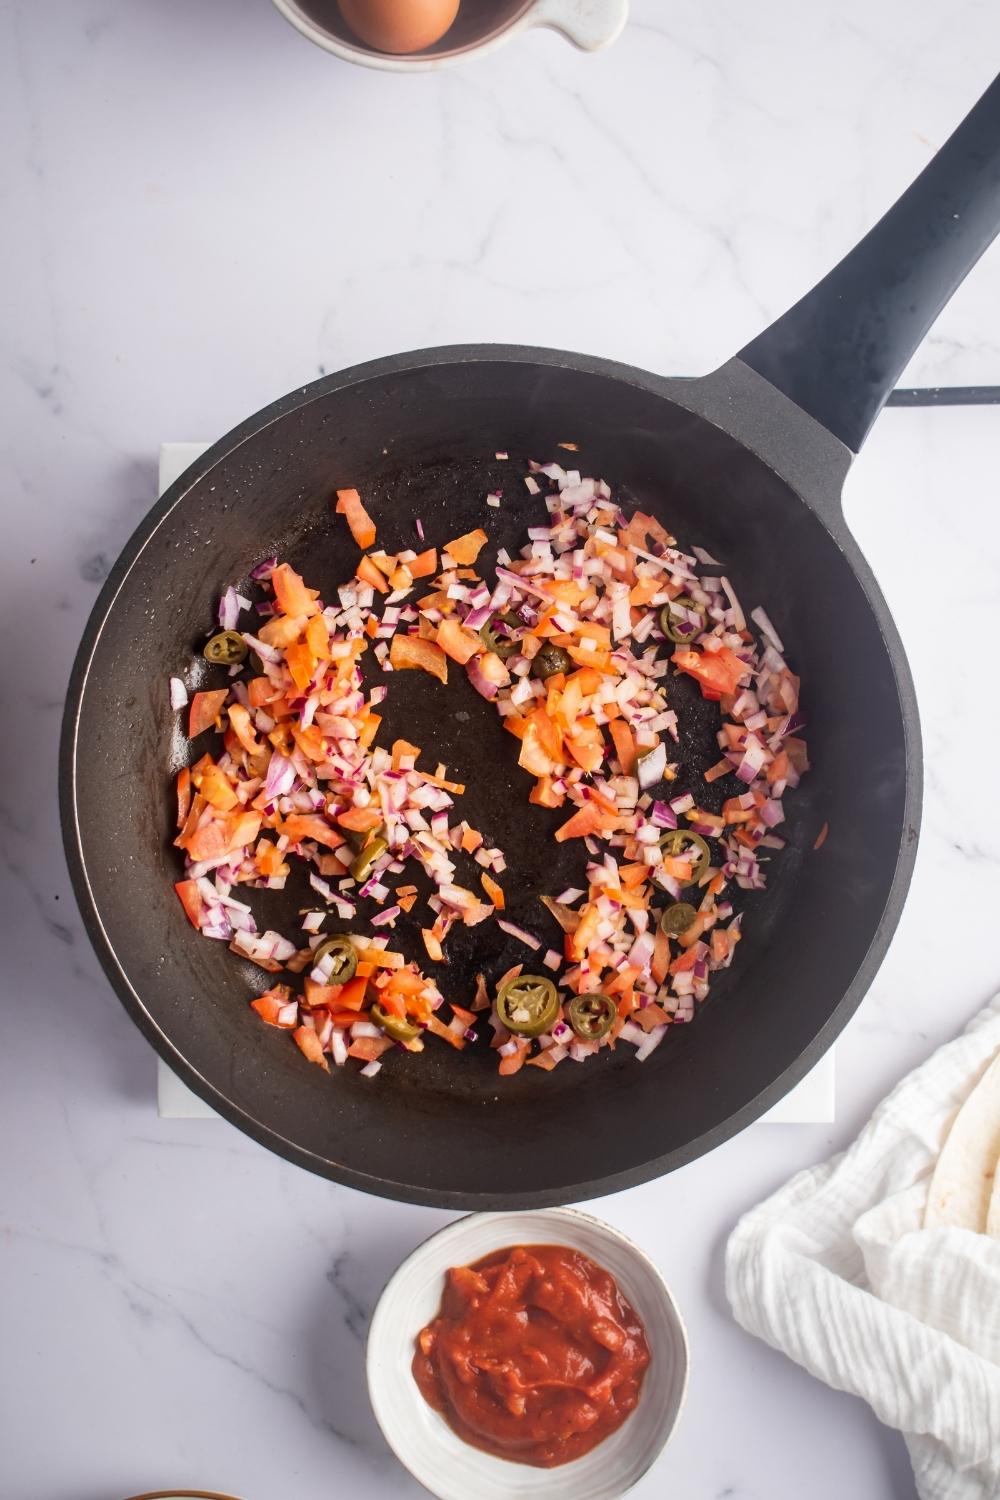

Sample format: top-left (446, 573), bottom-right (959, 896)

top-left (60, 81), bottom-right (1000, 1209)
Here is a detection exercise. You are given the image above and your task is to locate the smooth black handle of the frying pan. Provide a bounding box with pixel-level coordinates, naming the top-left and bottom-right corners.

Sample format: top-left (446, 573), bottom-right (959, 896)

top-left (738, 78), bottom-right (1000, 453)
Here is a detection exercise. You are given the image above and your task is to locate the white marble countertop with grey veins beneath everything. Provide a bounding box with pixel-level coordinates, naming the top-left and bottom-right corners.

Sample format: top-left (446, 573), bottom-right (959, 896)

top-left (0, 0), bottom-right (1000, 1500)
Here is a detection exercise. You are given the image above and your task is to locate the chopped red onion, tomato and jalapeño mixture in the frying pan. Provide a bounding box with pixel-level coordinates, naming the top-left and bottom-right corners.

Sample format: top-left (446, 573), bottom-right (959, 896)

top-left (169, 464), bottom-right (808, 1077)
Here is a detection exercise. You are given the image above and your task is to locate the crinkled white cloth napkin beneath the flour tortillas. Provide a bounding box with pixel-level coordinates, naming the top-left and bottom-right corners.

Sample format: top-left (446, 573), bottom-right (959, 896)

top-left (726, 996), bottom-right (1000, 1500)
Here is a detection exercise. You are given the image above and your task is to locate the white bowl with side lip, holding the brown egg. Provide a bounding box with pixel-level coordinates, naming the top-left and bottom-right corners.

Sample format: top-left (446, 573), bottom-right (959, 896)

top-left (273, 0), bottom-right (628, 74)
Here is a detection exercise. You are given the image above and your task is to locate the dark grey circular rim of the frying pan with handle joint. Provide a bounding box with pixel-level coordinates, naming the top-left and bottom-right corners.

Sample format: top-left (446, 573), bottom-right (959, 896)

top-left (58, 344), bottom-right (922, 1212)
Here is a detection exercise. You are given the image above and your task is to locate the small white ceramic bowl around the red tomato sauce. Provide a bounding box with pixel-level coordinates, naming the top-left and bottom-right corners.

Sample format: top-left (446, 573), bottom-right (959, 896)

top-left (366, 1209), bottom-right (690, 1500)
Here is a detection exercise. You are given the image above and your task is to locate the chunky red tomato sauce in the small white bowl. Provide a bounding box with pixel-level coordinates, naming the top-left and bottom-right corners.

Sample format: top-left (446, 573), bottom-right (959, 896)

top-left (412, 1245), bottom-right (649, 1469)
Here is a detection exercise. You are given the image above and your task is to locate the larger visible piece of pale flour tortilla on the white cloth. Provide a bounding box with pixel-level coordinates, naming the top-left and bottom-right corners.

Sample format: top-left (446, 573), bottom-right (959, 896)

top-left (924, 1055), bottom-right (1000, 1239)
